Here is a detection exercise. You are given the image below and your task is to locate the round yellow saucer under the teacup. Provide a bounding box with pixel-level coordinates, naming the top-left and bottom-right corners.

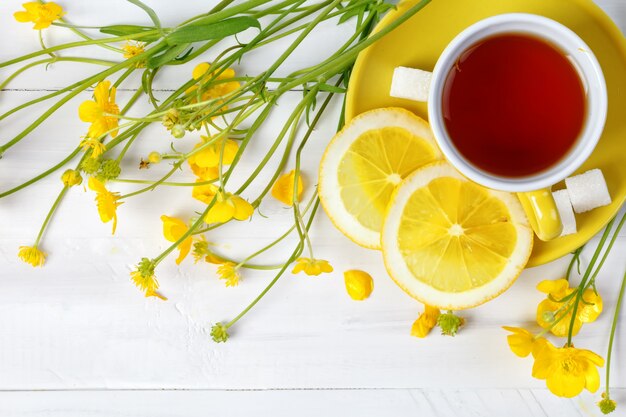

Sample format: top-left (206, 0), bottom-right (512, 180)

top-left (346, 0), bottom-right (626, 267)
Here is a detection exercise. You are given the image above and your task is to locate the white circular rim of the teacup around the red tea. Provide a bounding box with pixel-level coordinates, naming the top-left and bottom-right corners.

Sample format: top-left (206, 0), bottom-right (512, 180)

top-left (428, 13), bottom-right (608, 192)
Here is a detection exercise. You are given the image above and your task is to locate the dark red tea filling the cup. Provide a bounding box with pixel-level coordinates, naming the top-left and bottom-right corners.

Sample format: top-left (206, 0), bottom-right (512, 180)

top-left (442, 34), bottom-right (585, 177)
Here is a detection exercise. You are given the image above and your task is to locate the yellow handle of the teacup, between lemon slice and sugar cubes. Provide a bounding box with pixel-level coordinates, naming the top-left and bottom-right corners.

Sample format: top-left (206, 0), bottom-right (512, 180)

top-left (517, 188), bottom-right (563, 241)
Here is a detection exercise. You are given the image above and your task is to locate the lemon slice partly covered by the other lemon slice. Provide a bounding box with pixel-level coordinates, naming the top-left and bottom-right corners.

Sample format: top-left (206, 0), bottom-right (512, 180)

top-left (318, 108), bottom-right (441, 249)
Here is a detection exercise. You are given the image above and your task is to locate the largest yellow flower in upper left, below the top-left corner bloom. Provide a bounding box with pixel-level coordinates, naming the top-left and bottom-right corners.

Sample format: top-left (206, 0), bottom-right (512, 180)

top-left (78, 81), bottom-right (120, 139)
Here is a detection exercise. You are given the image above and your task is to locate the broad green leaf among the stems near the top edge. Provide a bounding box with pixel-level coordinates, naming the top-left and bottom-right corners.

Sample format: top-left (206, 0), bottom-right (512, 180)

top-left (165, 16), bottom-right (261, 45)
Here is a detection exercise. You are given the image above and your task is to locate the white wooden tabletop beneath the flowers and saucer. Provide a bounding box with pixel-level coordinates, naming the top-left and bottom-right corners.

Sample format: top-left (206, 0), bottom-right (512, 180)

top-left (0, 0), bottom-right (626, 417)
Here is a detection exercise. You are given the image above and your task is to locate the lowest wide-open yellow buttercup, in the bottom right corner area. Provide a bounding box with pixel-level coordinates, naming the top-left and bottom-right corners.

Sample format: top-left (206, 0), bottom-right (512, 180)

top-left (533, 341), bottom-right (604, 398)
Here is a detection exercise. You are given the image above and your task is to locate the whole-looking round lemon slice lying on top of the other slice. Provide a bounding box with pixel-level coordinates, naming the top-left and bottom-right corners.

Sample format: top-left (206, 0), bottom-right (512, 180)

top-left (382, 162), bottom-right (533, 310)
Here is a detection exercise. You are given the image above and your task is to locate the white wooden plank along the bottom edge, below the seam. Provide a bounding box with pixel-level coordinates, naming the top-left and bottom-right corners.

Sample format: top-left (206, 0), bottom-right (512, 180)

top-left (0, 389), bottom-right (626, 417)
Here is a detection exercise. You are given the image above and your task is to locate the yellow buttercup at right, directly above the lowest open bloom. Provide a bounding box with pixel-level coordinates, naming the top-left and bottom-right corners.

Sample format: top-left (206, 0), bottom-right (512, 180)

top-left (537, 279), bottom-right (603, 337)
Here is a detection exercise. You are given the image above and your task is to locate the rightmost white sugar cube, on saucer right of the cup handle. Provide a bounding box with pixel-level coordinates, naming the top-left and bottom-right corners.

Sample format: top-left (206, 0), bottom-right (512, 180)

top-left (565, 168), bottom-right (611, 213)
